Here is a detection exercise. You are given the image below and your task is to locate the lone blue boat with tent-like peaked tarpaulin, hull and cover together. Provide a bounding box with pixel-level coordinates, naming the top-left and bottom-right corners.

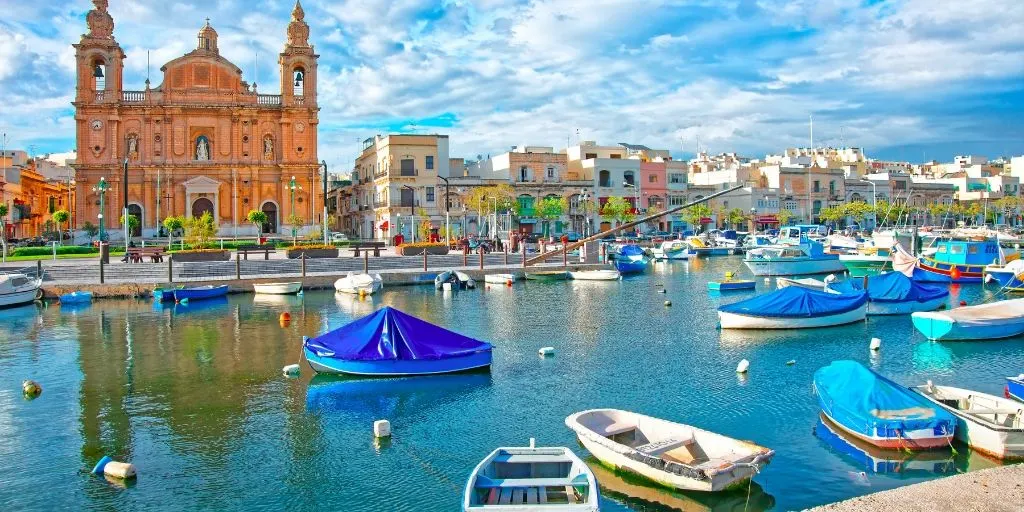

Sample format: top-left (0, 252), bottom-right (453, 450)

top-left (302, 306), bottom-right (490, 377)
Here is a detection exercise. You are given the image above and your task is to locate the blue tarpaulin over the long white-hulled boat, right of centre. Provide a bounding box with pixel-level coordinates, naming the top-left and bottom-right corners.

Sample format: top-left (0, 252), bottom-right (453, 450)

top-left (718, 287), bottom-right (867, 318)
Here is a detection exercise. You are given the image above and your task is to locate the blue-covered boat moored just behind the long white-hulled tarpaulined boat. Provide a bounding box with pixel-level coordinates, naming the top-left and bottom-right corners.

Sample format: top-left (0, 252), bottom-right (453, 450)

top-left (828, 272), bottom-right (949, 315)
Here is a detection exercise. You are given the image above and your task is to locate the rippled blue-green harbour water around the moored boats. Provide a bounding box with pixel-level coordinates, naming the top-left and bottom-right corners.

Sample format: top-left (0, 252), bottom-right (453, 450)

top-left (0, 257), bottom-right (1024, 511)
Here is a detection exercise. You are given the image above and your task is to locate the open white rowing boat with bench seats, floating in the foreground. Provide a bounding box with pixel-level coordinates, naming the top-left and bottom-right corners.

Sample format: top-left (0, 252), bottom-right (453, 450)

top-left (565, 409), bottom-right (775, 493)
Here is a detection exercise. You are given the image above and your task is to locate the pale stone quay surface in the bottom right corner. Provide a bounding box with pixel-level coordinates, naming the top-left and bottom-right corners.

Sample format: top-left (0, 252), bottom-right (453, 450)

top-left (810, 464), bottom-right (1024, 512)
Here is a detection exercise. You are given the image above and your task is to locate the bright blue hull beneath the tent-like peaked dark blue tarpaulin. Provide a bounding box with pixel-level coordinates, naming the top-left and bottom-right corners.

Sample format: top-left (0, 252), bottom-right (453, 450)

top-left (302, 347), bottom-right (490, 377)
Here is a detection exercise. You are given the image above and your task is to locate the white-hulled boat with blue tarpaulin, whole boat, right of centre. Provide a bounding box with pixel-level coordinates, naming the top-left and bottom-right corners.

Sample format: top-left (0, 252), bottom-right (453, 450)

top-left (718, 287), bottom-right (867, 329)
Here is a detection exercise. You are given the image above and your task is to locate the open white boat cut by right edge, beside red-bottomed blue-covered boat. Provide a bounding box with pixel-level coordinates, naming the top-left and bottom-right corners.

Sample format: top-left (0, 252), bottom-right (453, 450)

top-left (913, 381), bottom-right (1024, 459)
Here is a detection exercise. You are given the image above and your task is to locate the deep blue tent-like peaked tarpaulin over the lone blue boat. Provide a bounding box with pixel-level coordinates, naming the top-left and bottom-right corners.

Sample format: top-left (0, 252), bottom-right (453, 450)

top-left (306, 306), bottom-right (492, 360)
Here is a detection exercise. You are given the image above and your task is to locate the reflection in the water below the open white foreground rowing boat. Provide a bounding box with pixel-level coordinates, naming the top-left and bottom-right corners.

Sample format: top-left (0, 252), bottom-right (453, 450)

top-left (585, 457), bottom-right (775, 512)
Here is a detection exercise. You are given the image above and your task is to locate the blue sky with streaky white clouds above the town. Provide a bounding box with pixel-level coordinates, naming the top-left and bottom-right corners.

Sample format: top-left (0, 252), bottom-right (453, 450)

top-left (0, 0), bottom-right (1024, 170)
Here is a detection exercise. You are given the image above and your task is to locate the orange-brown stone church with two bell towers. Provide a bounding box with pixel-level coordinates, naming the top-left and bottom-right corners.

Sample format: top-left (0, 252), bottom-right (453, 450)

top-left (73, 0), bottom-right (326, 237)
